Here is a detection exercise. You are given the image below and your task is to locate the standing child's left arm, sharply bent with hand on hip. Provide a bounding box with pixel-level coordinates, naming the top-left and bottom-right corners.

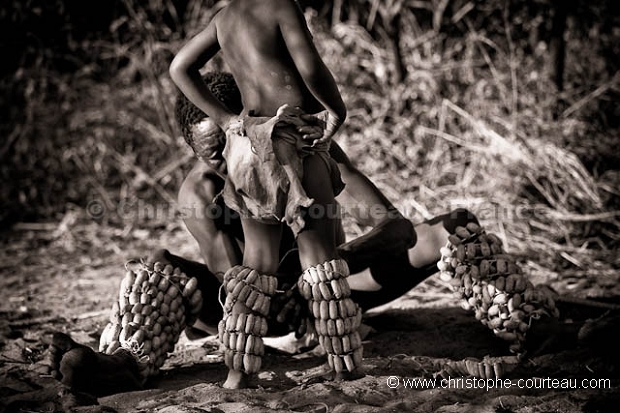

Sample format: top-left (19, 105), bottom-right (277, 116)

top-left (169, 15), bottom-right (237, 131)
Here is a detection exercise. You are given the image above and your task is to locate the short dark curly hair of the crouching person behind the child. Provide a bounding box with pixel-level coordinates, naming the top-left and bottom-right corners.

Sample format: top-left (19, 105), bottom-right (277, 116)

top-left (174, 72), bottom-right (243, 145)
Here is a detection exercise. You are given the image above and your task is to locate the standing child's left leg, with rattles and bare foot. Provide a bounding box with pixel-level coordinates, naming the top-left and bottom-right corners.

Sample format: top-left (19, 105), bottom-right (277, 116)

top-left (218, 218), bottom-right (282, 389)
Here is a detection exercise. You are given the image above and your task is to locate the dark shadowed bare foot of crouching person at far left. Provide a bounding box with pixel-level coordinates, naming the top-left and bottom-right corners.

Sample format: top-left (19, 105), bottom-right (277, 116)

top-left (49, 333), bottom-right (142, 397)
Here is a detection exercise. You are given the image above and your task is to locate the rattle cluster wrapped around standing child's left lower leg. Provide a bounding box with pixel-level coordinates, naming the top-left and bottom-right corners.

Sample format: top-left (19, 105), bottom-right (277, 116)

top-left (218, 265), bottom-right (278, 374)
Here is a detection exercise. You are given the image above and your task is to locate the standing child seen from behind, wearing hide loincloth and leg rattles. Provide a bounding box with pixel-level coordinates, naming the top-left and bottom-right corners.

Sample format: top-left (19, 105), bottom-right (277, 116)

top-left (170, 0), bottom-right (362, 388)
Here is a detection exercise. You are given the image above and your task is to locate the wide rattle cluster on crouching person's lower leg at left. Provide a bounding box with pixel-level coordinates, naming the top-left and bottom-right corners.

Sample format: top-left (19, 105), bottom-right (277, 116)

top-left (99, 261), bottom-right (202, 379)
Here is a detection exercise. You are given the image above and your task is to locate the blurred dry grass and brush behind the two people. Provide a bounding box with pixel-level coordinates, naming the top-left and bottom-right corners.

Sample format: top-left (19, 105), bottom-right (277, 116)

top-left (0, 0), bottom-right (620, 286)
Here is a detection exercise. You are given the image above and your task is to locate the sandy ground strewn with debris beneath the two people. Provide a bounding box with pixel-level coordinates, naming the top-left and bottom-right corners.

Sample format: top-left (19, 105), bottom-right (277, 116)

top-left (0, 230), bottom-right (620, 413)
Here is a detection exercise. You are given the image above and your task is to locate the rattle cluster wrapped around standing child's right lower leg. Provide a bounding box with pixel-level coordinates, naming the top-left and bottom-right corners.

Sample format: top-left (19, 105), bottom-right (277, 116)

top-left (297, 259), bottom-right (363, 373)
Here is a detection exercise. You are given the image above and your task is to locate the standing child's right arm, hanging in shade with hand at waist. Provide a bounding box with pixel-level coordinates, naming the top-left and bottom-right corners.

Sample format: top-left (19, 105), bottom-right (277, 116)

top-left (277, 1), bottom-right (347, 143)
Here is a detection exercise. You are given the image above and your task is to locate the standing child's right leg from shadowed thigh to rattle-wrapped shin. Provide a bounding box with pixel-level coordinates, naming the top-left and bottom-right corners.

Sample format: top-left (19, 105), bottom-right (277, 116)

top-left (297, 155), bottom-right (362, 376)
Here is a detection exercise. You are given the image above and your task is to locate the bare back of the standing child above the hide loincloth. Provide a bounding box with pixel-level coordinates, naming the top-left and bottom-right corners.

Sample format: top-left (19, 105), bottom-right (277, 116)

top-left (215, 0), bottom-right (324, 116)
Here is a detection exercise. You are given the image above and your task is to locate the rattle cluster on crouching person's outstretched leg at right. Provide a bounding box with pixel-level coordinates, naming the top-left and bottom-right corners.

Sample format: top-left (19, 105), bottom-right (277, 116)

top-left (437, 223), bottom-right (559, 356)
